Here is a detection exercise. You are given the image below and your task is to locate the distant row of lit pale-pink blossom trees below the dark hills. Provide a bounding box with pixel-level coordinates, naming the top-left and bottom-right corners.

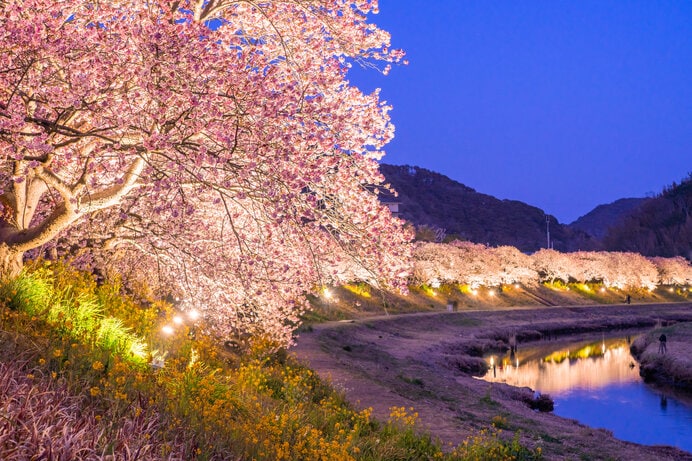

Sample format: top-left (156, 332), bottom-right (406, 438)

top-left (413, 241), bottom-right (692, 289)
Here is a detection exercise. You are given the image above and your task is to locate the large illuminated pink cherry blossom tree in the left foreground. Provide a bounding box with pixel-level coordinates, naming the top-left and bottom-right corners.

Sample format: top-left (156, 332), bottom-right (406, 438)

top-left (0, 0), bottom-right (409, 339)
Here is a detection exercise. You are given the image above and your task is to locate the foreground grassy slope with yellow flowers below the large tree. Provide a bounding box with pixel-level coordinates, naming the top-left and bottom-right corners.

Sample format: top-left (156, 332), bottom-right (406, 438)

top-left (0, 265), bottom-right (541, 460)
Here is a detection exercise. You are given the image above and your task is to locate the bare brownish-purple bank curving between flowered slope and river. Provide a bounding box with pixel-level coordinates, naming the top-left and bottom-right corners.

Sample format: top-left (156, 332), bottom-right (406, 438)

top-left (292, 303), bottom-right (692, 460)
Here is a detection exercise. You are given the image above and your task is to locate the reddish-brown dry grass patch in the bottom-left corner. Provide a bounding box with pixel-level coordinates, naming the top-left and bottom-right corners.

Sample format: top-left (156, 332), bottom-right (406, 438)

top-left (0, 361), bottom-right (187, 460)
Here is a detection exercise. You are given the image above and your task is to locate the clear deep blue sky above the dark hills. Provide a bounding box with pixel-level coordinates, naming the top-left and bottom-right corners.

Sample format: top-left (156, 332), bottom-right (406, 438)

top-left (349, 0), bottom-right (692, 223)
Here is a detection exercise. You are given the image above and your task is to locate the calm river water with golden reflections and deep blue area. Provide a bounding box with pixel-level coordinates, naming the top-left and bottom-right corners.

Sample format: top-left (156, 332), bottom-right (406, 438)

top-left (483, 337), bottom-right (692, 452)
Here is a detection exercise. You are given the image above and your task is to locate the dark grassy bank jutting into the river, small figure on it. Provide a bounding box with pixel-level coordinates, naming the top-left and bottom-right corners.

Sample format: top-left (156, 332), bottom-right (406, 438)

top-left (630, 322), bottom-right (692, 392)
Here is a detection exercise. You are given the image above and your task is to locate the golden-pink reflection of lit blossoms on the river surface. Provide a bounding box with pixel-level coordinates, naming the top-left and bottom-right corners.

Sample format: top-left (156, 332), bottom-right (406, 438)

top-left (483, 340), bottom-right (640, 395)
